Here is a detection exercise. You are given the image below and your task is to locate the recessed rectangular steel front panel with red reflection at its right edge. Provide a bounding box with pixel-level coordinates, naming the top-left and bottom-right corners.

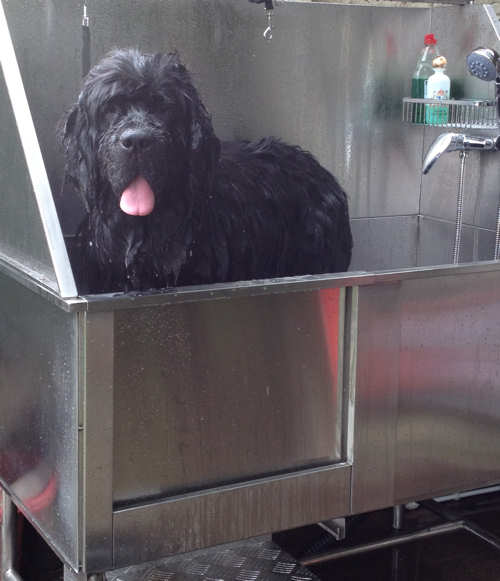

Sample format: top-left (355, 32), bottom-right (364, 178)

top-left (113, 289), bottom-right (342, 503)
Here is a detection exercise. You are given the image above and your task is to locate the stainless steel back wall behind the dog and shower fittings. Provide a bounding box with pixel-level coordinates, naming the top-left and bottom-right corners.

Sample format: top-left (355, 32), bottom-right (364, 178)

top-left (1, 0), bottom-right (498, 267)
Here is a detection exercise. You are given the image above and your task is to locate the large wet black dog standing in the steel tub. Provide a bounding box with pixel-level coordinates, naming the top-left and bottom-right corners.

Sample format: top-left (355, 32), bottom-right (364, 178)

top-left (62, 50), bottom-right (352, 293)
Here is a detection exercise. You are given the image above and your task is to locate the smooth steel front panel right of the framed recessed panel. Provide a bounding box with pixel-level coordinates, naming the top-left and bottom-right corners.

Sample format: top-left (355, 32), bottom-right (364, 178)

top-left (352, 271), bottom-right (500, 513)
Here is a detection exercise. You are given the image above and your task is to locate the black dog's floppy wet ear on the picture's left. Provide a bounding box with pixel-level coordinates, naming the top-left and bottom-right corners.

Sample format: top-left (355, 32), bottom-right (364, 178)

top-left (59, 103), bottom-right (97, 212)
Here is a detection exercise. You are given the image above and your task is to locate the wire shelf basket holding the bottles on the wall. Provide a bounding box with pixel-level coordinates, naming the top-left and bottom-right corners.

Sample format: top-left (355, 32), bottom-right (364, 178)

top-left (403, 97), bottom-right (498, 129)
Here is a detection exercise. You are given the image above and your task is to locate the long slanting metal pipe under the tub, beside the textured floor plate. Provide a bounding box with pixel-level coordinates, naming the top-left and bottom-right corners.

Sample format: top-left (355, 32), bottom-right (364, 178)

top-left (300, 521), bottom-right (464, 566)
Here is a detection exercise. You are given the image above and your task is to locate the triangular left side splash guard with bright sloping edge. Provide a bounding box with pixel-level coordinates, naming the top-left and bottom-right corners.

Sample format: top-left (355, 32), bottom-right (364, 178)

top-left (0, 2), bottom-right (77, 297)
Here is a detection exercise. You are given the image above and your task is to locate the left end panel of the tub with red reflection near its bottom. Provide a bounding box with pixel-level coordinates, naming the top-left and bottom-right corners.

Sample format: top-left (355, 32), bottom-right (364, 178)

top-left (0, 274), bottom-right (79, 566)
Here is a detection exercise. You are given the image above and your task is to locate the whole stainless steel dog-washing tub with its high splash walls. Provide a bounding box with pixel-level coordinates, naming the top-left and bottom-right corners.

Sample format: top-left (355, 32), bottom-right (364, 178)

top-left (0, 0), bottom-right (500, 575)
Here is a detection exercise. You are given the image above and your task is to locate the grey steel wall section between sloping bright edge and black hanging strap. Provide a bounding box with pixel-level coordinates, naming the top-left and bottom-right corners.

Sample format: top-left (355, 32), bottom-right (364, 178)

top-left (4, 0), bottom-right (83, 230)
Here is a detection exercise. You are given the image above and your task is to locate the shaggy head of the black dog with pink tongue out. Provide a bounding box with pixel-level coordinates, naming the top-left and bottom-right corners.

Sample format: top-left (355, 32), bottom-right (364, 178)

top-left (62, 49), bottom-right (220, 216)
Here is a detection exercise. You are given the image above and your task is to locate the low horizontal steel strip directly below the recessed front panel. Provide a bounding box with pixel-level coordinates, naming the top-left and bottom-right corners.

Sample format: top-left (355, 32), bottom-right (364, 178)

top-left (113, 465), bottom-right (351, 564)
